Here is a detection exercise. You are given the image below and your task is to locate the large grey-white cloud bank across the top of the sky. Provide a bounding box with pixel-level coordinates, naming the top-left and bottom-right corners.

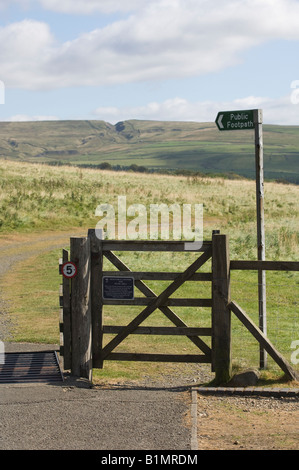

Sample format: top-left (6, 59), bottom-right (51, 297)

top-left (0, 0), bottom-right (299, 89)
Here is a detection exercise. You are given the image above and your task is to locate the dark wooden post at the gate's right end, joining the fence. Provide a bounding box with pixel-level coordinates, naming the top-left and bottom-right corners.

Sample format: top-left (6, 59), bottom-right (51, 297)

top-left (212, 233), bottom-right (232, 384)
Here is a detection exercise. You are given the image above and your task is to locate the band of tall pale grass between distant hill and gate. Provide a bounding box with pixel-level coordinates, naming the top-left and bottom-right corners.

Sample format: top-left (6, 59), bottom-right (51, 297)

top-left (0, 160), bottom-right (299, 260)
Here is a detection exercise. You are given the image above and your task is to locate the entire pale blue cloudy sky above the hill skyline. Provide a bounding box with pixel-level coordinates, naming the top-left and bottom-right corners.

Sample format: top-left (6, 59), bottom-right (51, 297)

top-left (0, 0), bottom-right (299, 125)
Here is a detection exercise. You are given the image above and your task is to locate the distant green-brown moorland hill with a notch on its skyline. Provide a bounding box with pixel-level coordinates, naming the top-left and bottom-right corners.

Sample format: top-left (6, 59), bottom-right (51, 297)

top-left (0, 120), bottom-right (299, 184)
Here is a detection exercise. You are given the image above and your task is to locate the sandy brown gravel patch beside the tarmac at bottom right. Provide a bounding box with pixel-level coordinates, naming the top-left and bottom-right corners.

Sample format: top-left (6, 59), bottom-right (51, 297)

top-left (197, 393), bottom-right (299, 450)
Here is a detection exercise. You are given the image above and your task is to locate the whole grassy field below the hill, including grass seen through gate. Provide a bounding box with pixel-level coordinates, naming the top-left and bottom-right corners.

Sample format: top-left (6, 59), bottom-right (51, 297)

top-left (0, 160), bottom-right (299, 384)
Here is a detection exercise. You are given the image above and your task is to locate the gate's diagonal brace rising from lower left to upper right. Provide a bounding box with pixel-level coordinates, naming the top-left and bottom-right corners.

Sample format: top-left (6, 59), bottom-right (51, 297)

top-left (102, 250), bottom-right (211, 359)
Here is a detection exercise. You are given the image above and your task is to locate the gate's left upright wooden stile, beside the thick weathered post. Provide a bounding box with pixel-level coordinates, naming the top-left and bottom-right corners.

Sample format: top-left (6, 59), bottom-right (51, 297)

top-left (88, 230), bottom-right (103, 369)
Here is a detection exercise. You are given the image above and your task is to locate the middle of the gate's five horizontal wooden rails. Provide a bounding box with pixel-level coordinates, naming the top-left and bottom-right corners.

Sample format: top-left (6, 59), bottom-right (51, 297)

top-left (103, 297), bottom-right (212, 308)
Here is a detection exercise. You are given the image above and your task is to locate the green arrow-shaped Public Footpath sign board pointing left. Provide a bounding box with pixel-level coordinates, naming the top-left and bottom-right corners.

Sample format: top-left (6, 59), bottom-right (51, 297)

top-left (215, 109), bottom-right (255, 131)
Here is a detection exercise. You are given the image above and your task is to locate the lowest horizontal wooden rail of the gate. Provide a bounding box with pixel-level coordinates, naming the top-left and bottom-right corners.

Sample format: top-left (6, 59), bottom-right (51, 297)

top-left (105, 353), bottom-right (211, 364)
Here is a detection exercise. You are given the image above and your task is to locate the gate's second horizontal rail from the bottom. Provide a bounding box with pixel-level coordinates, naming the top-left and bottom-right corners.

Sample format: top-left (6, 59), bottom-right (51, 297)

top-left (103, 325), bottom-right (212, 336)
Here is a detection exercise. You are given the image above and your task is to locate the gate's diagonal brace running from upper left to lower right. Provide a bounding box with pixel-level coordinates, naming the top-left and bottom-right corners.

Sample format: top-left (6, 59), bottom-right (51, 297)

top-left (104, 251), bottom-right (211, 355)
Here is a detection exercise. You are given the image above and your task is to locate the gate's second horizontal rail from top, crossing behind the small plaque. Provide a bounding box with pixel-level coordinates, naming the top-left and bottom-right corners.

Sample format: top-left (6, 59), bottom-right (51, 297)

top-left (103, 271), bottom-right (212, 282)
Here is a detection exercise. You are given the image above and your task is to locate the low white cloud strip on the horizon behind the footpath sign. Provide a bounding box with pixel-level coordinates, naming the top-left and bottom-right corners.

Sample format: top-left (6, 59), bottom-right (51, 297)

top-left (94, 96), bottom-right (299, 125)
